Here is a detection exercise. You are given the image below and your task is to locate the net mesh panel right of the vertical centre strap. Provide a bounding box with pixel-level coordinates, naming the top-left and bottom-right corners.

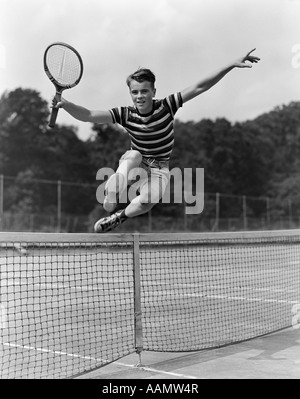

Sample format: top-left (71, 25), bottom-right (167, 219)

top-left (140, 237), bottom-right (300, 351)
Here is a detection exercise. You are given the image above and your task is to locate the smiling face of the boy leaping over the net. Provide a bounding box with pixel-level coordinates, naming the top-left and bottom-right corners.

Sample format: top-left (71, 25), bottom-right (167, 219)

top-left (129, 80), bottom-right (156, 114)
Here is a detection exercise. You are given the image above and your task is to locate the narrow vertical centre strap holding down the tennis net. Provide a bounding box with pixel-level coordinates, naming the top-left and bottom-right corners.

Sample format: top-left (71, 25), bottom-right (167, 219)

top-left (133, 233), bottom-right (143, 367)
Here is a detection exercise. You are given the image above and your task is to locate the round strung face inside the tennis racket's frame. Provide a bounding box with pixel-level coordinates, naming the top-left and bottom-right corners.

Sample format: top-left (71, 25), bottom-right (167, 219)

top-left (46, 45), bottom-right (82, 86)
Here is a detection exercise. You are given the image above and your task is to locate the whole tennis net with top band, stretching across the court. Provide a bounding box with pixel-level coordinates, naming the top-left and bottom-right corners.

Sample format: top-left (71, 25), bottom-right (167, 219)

top-left (0, 230), bottom-right (300, 378)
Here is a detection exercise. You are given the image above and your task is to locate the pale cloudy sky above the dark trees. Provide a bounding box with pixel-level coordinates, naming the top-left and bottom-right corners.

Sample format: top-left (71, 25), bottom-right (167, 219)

top-left (0, 0), bottom-right (300, 140)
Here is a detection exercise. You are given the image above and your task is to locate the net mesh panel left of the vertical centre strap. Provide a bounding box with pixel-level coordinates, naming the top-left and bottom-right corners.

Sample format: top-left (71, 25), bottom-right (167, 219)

top-left (0, 236), bottom-right (134, 378)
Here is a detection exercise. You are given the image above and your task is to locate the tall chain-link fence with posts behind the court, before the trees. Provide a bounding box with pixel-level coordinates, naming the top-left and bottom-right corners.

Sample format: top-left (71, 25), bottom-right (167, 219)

top-left (0, 175), bottom-right (300, 232)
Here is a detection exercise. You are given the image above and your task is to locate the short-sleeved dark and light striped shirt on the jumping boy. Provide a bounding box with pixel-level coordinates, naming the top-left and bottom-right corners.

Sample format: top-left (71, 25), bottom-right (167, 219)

top-left (110, 93), bottom-right (183, 161)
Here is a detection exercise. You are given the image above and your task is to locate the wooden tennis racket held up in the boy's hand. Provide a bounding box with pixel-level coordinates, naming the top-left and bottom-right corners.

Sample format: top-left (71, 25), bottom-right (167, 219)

top-left (44, 42), bottom-right (83, 128)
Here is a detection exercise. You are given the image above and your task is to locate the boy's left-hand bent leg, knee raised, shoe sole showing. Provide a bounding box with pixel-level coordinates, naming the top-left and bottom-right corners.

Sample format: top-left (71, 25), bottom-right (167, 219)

top-left (103, 150), bottom-right (142, 212)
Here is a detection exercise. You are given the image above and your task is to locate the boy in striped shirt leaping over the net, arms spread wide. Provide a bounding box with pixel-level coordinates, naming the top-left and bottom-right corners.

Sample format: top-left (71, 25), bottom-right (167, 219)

top-left (52, 49), bottom-right (260, 233)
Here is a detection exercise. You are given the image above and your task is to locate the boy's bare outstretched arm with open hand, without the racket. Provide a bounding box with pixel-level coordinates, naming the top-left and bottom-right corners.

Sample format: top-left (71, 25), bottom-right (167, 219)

top-left (181, 48), bottom-right (260, 102)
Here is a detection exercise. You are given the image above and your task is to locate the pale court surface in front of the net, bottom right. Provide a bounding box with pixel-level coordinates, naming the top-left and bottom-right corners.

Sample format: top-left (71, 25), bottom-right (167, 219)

top-left (77, 328), bottom-right (300, 386)
